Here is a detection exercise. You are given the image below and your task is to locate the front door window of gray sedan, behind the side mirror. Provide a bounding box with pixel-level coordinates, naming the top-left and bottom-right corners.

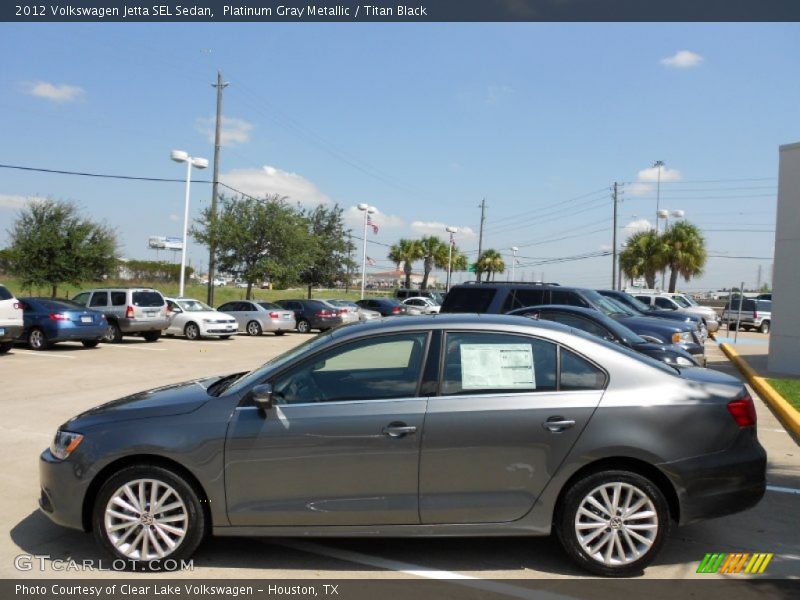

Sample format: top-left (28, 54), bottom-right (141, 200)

top-left (272, 332), bottom-right (428, 404)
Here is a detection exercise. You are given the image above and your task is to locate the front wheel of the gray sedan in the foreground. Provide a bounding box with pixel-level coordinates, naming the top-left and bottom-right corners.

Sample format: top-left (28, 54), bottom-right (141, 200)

top-left (92, 465), bottom-right (208, 570)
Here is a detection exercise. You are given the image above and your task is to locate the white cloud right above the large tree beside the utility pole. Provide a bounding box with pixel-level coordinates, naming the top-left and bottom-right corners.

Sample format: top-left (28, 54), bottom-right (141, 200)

top-left (220, 165), bottom-right (331, 206)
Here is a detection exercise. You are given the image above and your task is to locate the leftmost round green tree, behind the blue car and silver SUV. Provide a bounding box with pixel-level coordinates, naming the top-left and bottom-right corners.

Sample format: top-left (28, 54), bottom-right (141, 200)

top-left (7, 200), bottom-right (117, 298)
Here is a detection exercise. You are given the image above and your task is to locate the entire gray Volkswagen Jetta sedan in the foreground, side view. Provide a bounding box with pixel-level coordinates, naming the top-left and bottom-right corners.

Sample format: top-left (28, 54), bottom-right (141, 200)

top-left (40, 315), bottom-right (766, 576)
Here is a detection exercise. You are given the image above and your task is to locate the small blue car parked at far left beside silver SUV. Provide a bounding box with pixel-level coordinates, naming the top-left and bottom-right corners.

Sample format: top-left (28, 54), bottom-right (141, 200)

top-left (19, 298), bottom-right (108, 350)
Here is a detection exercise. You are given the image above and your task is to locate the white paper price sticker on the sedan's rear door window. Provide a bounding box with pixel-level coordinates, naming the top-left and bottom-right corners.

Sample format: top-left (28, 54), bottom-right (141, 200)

top-left (461, 344), bottom-right (536, 390)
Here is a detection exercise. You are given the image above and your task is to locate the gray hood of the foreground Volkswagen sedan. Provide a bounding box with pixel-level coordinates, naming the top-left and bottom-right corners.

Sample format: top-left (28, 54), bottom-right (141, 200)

top-left (62, 377), bottom-right (220, 430)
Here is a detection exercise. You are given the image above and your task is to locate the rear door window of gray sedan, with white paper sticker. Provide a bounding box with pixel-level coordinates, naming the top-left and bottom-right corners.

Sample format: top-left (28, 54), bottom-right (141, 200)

top-left (442, 332), bottom-right (557, 395)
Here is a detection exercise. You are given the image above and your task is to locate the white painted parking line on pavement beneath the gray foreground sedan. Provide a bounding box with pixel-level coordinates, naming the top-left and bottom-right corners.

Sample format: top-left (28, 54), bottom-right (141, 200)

top-left (270, 540), bottom-right (573, 600)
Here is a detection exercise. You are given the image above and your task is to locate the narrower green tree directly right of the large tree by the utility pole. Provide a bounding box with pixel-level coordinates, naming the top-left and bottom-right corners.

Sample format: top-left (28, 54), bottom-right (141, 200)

top-left (300, 204), bottom-right (354, 298)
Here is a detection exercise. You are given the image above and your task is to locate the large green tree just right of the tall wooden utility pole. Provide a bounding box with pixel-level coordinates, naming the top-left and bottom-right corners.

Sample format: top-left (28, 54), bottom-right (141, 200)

top-left (192, 195), bottom-right (313, 299)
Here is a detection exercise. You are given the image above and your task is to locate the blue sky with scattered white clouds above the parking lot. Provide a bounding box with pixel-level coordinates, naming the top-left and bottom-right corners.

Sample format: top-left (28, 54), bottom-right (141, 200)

top-left (0, 23), bottom-right (800, 290)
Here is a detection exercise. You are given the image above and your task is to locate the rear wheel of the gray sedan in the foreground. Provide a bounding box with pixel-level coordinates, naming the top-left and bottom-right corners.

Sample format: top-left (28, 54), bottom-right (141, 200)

top-left (555, 470), bottom-right (671, 577)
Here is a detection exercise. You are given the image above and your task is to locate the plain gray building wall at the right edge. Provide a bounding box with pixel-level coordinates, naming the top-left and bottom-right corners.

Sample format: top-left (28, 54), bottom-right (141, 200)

top-left (768, 143), bottom-right (800, 375)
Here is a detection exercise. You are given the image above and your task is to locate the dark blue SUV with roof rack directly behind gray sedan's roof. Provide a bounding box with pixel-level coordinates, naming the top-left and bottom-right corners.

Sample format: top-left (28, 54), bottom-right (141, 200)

top-left (441, 282), bottom-right (705, 364)
